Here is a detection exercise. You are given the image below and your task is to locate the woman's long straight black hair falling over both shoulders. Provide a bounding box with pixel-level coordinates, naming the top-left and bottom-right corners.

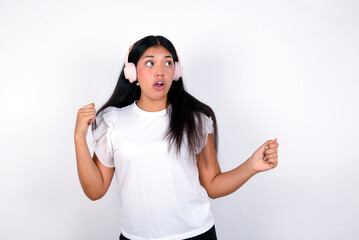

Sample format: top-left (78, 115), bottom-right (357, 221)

top-left (92, 35), bottom-right (218, 156)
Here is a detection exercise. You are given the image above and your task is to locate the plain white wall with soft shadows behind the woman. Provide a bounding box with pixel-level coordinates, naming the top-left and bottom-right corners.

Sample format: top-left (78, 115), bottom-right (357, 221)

top-left (0, 0), bottom-right (359, 240)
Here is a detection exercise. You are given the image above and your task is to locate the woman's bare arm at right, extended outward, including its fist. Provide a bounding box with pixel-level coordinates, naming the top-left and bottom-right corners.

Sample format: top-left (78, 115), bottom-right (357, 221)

top-left (197, 134), bottom-right (279, 199)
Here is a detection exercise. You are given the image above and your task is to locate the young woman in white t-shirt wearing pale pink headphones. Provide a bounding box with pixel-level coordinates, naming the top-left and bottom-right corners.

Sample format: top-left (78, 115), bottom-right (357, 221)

top-left (74, 36), bottom-right (279, 240)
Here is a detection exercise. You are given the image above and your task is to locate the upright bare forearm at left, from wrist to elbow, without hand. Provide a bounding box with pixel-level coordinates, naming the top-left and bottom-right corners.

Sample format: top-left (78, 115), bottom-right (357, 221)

top-left (75, 138), bottom-right (105, 200)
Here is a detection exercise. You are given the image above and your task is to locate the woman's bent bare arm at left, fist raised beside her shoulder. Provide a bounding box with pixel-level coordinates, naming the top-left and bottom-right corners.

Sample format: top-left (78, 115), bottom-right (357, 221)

top-left (74, 103), bottom-right (115, 200)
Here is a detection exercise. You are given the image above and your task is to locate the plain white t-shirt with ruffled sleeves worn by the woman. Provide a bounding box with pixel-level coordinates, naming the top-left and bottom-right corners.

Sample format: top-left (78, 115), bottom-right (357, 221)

top-left (93, 100), bottom-right (214, 240)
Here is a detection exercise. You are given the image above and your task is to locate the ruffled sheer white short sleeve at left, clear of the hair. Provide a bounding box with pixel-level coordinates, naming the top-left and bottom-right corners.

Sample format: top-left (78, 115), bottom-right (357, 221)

top-left (92, 106), bottom-right (117, 167)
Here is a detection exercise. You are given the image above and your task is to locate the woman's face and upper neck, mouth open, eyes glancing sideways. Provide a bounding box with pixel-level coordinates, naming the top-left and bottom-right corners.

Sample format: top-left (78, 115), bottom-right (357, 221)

top-left (136, 46), bottom-right (175, 106)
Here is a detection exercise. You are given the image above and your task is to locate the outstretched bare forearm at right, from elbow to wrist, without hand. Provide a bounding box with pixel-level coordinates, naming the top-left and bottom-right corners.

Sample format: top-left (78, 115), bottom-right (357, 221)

top-left (209, 159), bottom-right (255, 198)
